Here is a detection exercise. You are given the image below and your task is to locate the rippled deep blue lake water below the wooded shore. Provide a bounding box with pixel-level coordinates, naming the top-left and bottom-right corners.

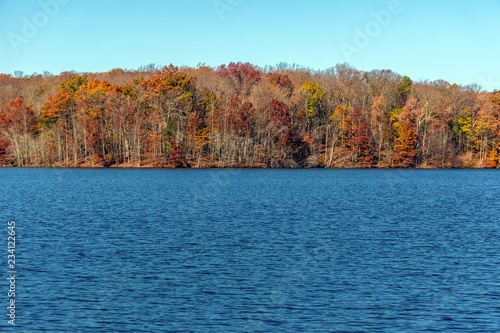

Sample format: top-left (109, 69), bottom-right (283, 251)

top-left (0, 169), bottom-right (500, 332)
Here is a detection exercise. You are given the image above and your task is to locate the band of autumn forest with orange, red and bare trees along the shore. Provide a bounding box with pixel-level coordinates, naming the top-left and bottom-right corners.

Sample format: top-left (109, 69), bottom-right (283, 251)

top-left (0, 62), bottom-right (500, 168)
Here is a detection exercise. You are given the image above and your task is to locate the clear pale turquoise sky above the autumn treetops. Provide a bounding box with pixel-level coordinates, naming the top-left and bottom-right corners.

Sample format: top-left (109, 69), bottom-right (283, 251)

top-left (0, 0), bottom-right (500, 90)
